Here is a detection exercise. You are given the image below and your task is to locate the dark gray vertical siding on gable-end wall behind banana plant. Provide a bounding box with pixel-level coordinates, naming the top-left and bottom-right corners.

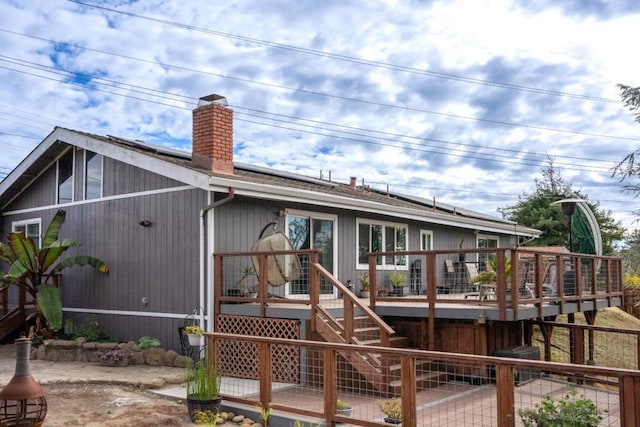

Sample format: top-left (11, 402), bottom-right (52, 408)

top-left (2, 151), bottom-right (207, 349)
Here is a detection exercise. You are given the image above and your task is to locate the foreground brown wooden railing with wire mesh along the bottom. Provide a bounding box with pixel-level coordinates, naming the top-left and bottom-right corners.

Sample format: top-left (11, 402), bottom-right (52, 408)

top-left (206, 333), bottom-right (640, 427)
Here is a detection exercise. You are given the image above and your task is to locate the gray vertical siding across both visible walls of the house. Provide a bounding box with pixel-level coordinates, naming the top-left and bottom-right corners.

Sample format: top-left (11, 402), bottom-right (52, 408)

top-left (2, 150), bottom-right (520, 350)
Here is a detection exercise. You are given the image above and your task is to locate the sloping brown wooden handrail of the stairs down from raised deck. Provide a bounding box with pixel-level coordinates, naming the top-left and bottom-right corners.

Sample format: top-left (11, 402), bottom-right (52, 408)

top-left (310, 262), bottom-right (395, 347)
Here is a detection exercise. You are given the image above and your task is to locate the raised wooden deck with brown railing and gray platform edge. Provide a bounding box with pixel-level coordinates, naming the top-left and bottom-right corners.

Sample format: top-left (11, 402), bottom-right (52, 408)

top-left (214, 248), bottom-right (624, 321)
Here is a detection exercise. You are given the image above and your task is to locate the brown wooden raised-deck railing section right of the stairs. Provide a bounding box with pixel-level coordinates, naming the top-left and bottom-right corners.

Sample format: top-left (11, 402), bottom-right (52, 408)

top-left (368, 248), bottom-right (623, 320)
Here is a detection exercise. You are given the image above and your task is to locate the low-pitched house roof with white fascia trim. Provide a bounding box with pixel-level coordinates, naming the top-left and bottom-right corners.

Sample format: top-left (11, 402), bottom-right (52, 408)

top-left (0, 127), bottom-right (540, 237)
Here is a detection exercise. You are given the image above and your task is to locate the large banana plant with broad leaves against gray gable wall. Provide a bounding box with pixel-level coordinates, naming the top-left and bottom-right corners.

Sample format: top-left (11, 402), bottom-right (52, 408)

top-left (0, 210), bottom-right (109, 338)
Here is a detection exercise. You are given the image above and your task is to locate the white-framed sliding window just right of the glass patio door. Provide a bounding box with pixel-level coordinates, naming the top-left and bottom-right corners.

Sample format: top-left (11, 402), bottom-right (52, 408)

top-left (357, 220), bottom-right (407, 268)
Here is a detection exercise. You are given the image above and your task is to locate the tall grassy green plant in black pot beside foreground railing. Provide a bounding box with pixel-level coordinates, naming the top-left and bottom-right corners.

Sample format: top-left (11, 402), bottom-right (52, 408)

top-left (185, 358), bottom-right (222, 422)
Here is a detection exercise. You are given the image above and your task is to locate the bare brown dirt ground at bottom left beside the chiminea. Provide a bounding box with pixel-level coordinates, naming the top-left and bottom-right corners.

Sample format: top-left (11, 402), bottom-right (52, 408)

top-left (0, 344), bottom-right (193, 427)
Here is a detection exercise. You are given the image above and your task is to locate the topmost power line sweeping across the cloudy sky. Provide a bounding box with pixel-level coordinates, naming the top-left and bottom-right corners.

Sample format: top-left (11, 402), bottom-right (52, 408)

top-left (67, 0), bottom-right (620, 103)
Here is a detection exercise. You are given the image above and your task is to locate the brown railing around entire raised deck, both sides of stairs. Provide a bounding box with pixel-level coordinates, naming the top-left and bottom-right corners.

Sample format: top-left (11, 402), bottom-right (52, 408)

top-left (214, 248), bottom-right (624, 321)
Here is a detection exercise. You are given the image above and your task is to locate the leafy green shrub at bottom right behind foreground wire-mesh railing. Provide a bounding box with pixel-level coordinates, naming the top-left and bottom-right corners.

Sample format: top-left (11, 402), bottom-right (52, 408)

top-left (518, 388), bottom-right (605, 427)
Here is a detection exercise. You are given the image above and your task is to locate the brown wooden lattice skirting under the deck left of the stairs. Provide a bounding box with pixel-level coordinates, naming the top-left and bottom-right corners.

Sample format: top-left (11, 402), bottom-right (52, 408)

top-left (216, 314), bottom-right (300, 384)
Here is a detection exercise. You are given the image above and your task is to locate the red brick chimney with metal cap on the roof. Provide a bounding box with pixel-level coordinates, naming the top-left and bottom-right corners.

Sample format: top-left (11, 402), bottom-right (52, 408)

top-left (191, 94), bottom-right (233, 175)
